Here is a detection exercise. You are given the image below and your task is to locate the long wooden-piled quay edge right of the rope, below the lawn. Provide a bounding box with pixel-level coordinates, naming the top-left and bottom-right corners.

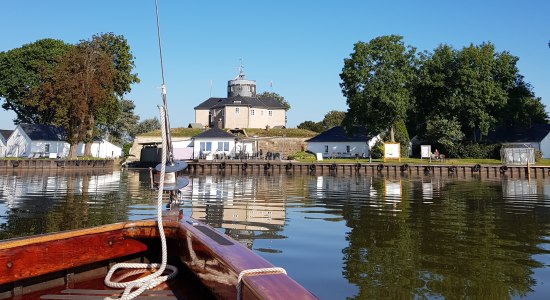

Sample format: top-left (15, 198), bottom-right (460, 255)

top-left (187, 160), bottom-right (550, 178)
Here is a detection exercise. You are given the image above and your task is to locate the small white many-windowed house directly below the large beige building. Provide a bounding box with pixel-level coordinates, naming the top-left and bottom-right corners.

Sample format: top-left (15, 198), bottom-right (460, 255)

top-left (193, 128), bottom-right (253, 159)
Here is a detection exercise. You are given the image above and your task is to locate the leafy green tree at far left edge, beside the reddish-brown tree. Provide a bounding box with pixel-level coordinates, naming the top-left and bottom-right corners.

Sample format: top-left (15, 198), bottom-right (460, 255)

top-left (0, 39), bottom-right (73, 124)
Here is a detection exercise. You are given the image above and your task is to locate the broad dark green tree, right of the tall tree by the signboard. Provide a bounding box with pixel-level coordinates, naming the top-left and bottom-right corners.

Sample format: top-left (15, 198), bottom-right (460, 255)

top-left (409, 43), bottom-right (528, 142)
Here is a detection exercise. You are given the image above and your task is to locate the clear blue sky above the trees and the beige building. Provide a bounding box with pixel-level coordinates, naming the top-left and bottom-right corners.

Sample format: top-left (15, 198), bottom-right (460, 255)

top-left (0, 0), bottom-right (550, 129)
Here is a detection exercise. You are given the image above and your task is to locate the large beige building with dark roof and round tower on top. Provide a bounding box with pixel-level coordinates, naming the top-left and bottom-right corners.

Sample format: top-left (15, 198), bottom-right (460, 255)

top-left (195, 68), bottom-right (286, 128)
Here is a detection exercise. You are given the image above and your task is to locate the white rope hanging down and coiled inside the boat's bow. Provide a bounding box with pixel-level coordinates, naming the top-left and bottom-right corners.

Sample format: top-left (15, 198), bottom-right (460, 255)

top-left (104, 107), bottom-right (178, 300)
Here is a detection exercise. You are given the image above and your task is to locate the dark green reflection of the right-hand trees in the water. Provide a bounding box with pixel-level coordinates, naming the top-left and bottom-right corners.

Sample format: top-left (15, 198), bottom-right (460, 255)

top-left (343, 180), bottom-right (547, 299)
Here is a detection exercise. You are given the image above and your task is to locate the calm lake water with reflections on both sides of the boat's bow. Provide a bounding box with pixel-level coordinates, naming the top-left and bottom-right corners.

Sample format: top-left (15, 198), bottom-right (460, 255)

top-left (0, 170), bottom-right (550, 299)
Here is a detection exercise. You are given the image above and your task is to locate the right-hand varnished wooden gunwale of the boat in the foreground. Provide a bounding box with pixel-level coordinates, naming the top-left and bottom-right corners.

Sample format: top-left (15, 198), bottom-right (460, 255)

top-left (178, 214), bottom-right (317, 299)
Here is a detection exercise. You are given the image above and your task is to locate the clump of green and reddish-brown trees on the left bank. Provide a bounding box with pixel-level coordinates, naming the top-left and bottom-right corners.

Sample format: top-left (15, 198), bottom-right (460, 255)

top-left (0, 33), bottom-right (139, 156)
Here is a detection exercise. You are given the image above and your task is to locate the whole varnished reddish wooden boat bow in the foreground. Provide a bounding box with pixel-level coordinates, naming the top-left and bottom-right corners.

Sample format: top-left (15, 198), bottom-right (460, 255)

top-left (0, 210), bottom-right (316, 299)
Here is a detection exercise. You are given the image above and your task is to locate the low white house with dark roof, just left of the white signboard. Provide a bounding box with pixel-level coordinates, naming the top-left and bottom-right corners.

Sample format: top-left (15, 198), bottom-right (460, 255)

top-left (306, 126), bottom-right (380, 158)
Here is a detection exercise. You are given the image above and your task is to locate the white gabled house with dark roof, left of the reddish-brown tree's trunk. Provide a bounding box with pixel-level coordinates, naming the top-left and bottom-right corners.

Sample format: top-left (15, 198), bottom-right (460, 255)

top-left (5, 124), bottom-right (70, 157)
